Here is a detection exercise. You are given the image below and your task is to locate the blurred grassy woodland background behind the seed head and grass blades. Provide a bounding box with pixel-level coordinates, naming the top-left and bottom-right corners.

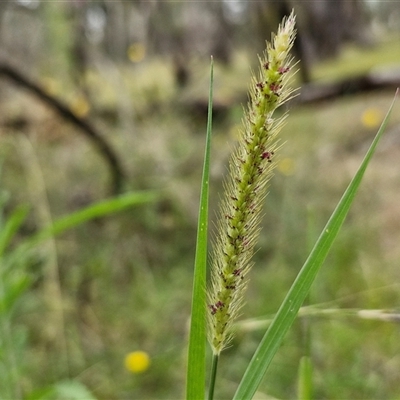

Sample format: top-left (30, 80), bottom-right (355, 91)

top-left (0, 0), bottom-right (400, 400)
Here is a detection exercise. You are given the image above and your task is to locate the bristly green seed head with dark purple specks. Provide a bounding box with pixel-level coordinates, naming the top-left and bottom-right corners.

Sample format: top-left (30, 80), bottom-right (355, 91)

top-left (207, 12), bottom-right (295, 354)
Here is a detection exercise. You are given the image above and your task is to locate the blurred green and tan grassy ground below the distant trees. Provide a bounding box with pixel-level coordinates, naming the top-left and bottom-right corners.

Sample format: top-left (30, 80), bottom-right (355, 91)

top-left (0, 35), bottom-right (400, 400)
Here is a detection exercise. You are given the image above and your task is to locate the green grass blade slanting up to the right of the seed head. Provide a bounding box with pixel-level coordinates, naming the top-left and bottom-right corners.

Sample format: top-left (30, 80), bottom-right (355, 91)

top-left (234, 90), bottom-right (398, 399)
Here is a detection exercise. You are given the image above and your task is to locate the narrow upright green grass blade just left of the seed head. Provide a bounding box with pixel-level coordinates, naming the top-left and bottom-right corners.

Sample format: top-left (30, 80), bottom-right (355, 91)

top-left (186, 59), bottom-right (214, 400)
